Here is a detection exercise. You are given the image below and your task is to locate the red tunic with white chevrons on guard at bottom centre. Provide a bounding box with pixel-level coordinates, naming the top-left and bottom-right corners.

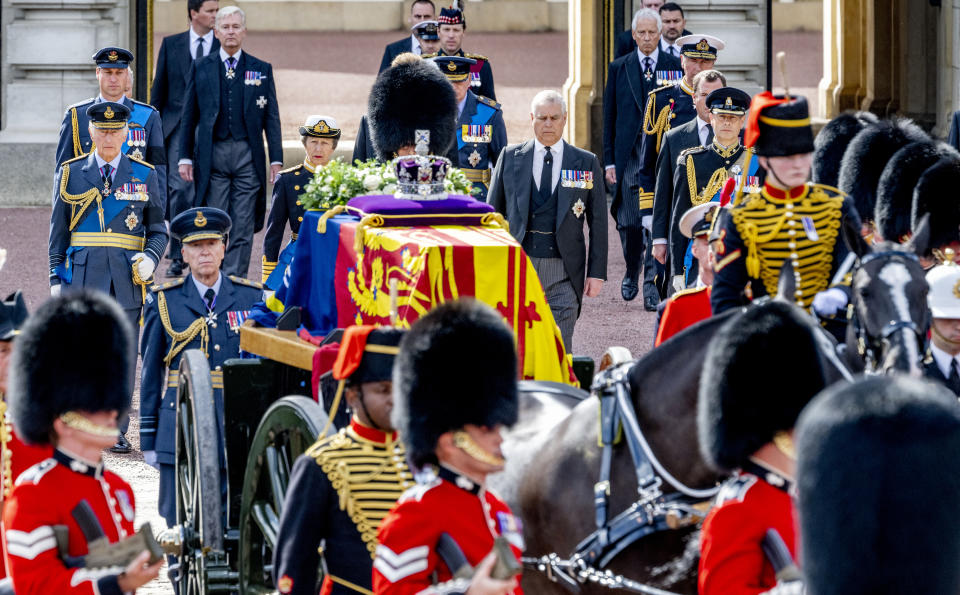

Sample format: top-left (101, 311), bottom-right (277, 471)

top-left (373, 467), bottom-right (523, 595)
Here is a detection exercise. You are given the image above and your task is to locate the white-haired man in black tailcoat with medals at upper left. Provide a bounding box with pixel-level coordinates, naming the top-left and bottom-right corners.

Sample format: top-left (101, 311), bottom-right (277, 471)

top-left (179, 6), bottom-right (283, 277)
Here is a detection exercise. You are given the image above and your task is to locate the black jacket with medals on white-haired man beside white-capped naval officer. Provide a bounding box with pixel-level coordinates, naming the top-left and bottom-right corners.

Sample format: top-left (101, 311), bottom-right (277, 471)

top-left (603, 46), bottom-right (680, 213)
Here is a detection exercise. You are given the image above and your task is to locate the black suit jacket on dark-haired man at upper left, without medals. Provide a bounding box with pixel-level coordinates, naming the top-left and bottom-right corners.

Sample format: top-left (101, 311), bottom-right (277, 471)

top-left (150, 31), bottom-right (220, 141)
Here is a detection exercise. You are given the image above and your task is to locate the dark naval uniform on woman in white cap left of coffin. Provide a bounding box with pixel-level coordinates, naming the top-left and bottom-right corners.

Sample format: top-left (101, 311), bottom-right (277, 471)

top-left (262, 161), bottom-right (315, 283)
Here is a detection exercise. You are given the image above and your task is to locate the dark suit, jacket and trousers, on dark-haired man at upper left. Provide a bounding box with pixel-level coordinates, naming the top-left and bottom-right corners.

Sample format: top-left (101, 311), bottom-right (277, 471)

top-left (150, 31), bottom-right (220, 260)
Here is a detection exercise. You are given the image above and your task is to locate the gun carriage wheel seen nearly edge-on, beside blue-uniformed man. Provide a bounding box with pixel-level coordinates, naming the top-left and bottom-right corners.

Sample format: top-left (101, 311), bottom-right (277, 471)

top-left (175, 349), bottom-right (230, 595)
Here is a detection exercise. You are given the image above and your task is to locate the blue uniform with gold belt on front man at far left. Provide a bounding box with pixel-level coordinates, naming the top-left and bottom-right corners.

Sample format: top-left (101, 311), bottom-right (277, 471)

top-left (48, 153), bottom-right (167, 318)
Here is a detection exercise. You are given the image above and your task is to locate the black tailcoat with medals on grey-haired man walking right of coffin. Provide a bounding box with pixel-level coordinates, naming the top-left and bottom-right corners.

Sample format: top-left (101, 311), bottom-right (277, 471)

top-left (487, 139), bottom-right (607, 303)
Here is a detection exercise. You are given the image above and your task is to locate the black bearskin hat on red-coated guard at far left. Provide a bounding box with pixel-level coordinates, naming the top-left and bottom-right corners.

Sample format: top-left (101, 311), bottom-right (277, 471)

top-left (9, 291), bottom-right (134, 444)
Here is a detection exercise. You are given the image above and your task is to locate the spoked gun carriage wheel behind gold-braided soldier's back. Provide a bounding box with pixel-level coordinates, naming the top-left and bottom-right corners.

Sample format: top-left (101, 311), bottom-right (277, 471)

top-left (239, 396), bottom-right (334, 593)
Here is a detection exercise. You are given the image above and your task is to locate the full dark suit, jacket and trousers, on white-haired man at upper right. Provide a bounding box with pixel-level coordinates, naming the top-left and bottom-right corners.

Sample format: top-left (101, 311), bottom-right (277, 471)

top-left (603, 51), bottom-right (680, 298)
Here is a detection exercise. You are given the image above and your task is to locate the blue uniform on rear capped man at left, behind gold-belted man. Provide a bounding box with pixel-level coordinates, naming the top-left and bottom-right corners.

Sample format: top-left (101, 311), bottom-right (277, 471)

top-left (57, 96), bottom-right (167, 201)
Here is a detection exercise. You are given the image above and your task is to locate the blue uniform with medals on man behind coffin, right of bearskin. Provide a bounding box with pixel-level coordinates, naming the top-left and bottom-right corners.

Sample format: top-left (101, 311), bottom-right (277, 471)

top-left (455, 91), bottom-right (507, 201)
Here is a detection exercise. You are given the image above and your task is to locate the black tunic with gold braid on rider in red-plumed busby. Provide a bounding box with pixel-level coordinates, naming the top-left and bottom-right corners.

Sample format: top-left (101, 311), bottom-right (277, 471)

top-left (710, 183), bottom-right (860, 314)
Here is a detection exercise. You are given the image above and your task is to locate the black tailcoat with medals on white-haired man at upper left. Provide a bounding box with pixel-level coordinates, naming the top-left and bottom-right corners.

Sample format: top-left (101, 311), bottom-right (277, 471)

top-left (180, 52), bottom-right (283, 231)
